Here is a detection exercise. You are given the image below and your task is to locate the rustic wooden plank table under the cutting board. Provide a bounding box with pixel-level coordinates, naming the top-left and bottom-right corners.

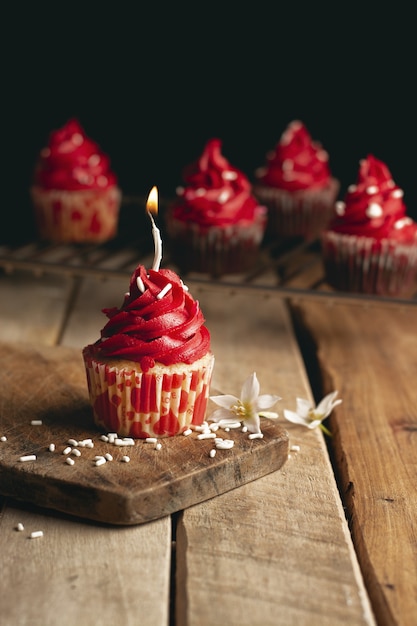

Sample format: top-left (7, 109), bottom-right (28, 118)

top-left (0, 252), bottom-right (417, 626)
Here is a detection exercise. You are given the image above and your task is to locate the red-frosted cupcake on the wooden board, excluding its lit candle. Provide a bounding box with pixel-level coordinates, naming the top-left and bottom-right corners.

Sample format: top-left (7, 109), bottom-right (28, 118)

top-left (83, 256), bottom-right (214, 438)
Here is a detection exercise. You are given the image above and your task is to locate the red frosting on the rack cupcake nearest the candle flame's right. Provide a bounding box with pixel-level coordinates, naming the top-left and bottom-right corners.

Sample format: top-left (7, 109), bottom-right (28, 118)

top-left (173, 139), bottom-right (258, 228)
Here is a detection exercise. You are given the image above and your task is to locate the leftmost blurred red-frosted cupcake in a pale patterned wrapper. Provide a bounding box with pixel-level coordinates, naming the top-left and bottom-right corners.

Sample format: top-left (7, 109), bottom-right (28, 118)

top-left (30, 119), bottom-right (121, 243)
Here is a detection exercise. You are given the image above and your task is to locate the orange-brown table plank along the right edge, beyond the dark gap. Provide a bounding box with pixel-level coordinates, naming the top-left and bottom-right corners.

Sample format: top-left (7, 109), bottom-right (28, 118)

top-left (290, 303), bottom-right (417, 626)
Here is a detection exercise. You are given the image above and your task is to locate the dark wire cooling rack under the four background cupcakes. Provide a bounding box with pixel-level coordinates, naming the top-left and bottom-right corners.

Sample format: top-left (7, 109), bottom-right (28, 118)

top-left (0, 197), bottom-right (417, 307)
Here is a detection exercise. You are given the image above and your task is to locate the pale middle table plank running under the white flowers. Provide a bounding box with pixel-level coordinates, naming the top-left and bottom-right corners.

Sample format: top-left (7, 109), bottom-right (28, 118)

top-left (172, 289), bottom-right (374, 626)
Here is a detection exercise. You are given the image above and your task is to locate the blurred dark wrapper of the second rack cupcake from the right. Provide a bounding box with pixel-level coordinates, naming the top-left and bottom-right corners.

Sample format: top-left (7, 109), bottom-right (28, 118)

top-left (254, 179), bottom-right (340, 241)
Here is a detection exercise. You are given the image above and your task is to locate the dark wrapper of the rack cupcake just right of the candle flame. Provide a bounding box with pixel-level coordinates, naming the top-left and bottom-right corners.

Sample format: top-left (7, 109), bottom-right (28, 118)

top-left (166, 206), bottom-right (266, 277)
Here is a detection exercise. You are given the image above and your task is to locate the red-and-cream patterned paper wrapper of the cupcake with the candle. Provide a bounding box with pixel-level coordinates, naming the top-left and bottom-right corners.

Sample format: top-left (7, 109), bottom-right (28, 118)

top-left (84, 355), bottom-right (214, 439)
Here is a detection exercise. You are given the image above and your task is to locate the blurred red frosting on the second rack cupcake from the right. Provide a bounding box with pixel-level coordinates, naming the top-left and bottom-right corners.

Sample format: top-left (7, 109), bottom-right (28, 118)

top-left (255, 120), bottom-right (331, 191)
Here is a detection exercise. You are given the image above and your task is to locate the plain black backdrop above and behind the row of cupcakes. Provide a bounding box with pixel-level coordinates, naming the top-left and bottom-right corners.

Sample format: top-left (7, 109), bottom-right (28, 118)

top-left (2, 2), bottom-right (417, 240)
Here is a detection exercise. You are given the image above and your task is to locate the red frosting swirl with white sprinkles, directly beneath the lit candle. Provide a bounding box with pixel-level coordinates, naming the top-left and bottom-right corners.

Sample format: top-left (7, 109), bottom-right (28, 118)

top-left (85, 265), bottom-right (210, 371)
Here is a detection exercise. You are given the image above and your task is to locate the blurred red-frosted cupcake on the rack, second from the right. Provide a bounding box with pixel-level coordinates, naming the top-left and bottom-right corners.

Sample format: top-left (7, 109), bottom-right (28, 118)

top-left (253, 120), bottom-right (340, 241)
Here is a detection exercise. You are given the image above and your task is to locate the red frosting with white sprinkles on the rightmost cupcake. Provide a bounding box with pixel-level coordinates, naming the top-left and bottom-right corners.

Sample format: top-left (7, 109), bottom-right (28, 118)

top-left (329, 154), bottom-right (417, 241)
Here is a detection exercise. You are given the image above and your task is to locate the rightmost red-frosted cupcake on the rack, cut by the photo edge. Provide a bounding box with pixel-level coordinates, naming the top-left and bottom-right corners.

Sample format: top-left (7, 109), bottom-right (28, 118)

top-left (321, 154), bottom-right (417, 296)
